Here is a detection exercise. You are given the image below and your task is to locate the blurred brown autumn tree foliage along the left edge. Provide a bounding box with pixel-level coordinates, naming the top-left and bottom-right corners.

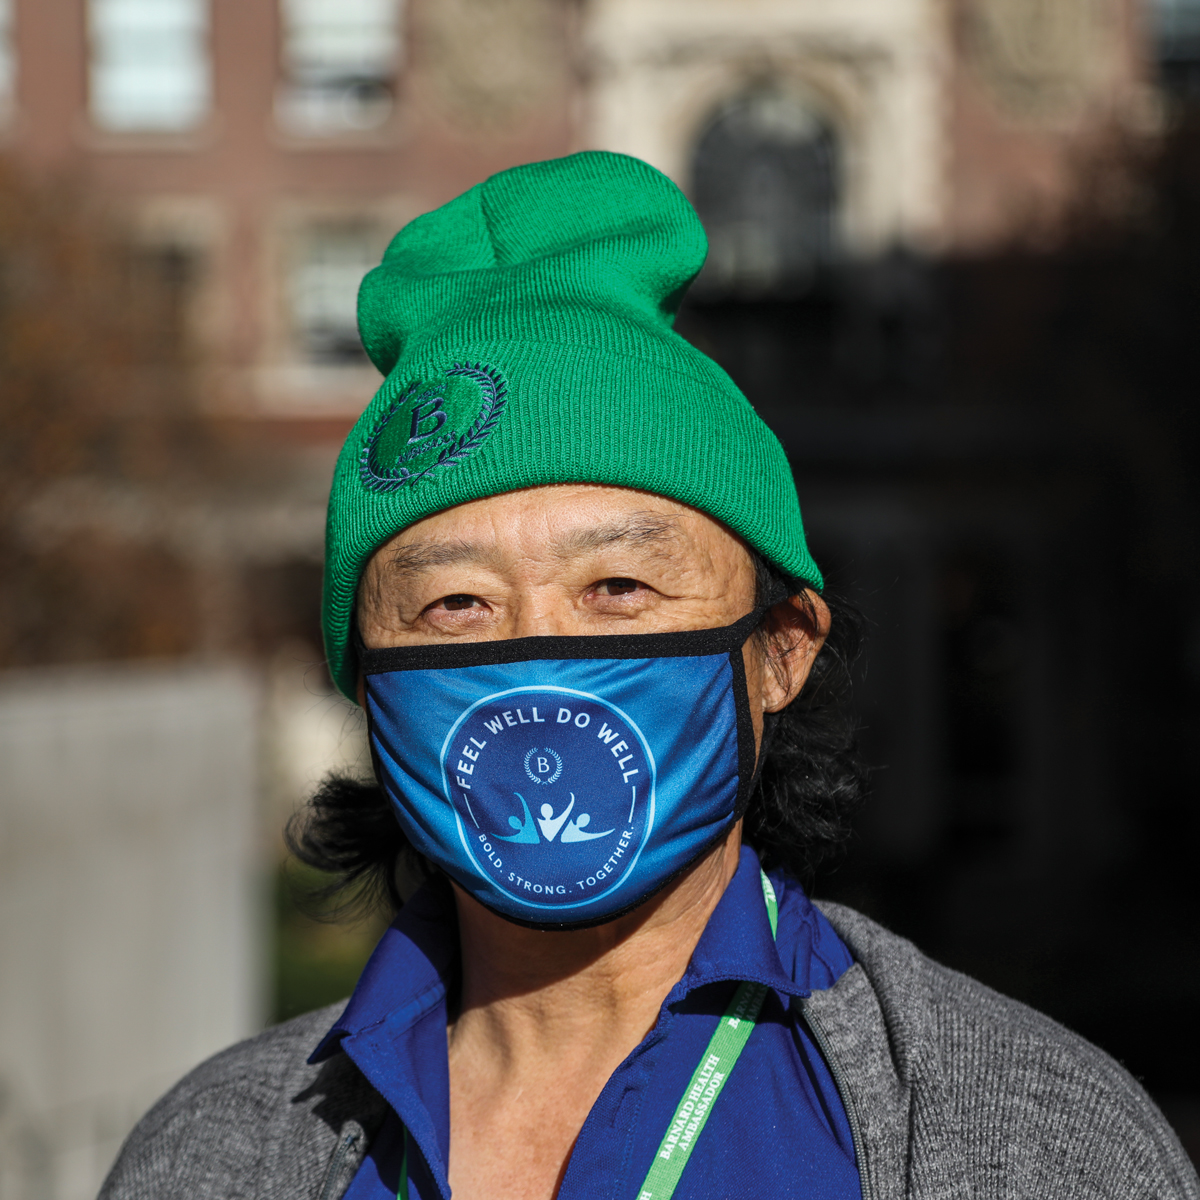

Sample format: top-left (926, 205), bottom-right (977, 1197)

top-left (0, 163), bottom-right (217, 666)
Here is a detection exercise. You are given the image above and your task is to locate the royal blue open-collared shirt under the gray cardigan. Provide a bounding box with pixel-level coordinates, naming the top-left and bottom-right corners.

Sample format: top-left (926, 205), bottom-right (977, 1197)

top-left (311, 847), bottom-right (862, 1200)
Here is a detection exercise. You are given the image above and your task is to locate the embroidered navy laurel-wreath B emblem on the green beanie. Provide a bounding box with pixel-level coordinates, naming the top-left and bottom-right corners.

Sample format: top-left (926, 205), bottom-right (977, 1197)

top-left (359, 362), bottom-right (508, 492)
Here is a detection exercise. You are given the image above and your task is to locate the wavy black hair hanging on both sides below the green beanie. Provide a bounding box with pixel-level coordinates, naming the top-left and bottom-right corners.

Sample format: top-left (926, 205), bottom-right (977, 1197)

top-left (284, 554), bottom-right (868, 916)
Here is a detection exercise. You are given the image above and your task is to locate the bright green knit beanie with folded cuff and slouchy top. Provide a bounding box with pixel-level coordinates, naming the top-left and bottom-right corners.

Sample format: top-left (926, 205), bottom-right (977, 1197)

top-left (323, 151), bottom-right (821, 697)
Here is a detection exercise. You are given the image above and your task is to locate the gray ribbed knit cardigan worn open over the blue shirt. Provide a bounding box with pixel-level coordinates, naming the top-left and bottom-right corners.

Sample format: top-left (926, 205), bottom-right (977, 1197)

top-left (101, 905), bottom-right (1200, 1200)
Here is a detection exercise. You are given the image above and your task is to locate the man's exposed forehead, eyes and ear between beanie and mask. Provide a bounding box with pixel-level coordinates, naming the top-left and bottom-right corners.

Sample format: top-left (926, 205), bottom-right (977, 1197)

top-left (358, 484), bottom-right (829, 739)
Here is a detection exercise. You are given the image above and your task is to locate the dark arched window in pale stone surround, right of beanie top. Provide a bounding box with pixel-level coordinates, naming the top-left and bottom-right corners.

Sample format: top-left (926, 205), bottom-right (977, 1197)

top-left (691, 91), bottom-right (839, 294)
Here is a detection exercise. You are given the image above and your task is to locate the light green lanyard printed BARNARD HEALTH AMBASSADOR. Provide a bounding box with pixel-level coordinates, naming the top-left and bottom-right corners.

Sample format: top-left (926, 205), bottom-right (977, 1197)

top-left (396, 871), bottom-right (779, 1200)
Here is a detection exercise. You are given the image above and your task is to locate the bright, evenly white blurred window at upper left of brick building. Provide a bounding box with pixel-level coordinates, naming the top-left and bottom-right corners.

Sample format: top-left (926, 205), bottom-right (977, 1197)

top-left (89, 0), bottom-right (212, 133)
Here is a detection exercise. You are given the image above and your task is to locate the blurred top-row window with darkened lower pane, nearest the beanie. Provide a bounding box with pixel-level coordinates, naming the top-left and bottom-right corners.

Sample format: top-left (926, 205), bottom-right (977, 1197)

top-left (276, 0), bottom-right (403, 137)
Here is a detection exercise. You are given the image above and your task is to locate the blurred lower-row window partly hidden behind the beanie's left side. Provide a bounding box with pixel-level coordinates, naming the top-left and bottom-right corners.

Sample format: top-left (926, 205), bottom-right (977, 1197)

top-left (288, 221), bottom-right (382, 366)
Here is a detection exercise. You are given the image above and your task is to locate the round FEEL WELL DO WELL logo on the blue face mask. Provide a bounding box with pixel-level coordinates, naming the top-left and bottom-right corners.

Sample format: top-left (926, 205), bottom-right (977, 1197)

top-left (442, 686), bottom-right (654, 917)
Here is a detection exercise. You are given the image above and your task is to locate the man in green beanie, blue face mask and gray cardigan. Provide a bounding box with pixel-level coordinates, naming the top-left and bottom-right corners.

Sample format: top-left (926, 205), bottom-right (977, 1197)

top-left (102, 152), bottom-right (1200, 1200)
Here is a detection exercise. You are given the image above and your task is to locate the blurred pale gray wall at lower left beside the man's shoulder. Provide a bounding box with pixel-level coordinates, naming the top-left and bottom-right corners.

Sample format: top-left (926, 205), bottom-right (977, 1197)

top-left (0, 666), bottom-right (265, 1200)
